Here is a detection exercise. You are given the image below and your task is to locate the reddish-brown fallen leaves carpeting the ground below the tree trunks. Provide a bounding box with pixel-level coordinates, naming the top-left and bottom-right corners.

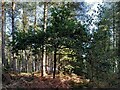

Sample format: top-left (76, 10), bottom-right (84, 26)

top-left (4, 73), bottom-right (89, 89)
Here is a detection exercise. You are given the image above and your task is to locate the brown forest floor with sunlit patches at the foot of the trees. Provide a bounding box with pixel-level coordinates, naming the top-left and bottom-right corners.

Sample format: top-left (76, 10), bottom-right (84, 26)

top-left (3, 73), bottom-right (90, 90)
